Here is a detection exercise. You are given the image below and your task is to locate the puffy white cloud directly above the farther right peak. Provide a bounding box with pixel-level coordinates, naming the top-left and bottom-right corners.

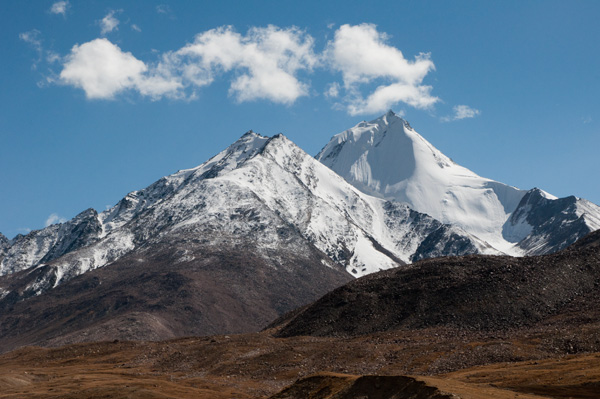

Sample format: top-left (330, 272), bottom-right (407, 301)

top-left (324, 24), bottom-right (439, 115)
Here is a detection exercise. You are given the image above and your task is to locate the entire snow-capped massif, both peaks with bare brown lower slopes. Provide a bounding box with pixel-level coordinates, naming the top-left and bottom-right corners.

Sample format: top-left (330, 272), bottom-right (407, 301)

top-left (0, 113), bottom-right (600, 351)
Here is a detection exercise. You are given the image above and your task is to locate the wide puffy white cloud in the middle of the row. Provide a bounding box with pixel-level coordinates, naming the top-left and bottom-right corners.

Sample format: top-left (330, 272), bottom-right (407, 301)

top-left (168, 26), bottom-right (317, 104)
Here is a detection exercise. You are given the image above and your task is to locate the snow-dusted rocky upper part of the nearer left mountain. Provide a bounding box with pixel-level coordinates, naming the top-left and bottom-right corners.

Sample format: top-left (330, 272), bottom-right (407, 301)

top-left (0, 128), bottom-right (496, 296)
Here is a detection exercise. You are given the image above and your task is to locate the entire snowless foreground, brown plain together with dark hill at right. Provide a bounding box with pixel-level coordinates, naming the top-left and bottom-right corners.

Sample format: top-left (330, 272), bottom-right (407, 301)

top-left (0, 232), bottom-right (600, 399)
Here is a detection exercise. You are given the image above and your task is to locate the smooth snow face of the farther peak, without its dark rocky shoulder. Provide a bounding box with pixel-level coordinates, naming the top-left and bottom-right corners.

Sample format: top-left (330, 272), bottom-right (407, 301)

top-left (317, 111), bottom-right (536, 255)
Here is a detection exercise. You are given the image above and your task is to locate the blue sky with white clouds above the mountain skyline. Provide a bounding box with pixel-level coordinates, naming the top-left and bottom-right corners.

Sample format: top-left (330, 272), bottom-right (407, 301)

top-left (0, 0), bottom-right (600, 238)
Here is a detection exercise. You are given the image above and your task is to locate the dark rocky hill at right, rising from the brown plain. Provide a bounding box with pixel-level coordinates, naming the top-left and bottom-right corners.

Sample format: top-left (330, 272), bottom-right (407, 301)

top-left (278, 232), bottom-right (600, 337)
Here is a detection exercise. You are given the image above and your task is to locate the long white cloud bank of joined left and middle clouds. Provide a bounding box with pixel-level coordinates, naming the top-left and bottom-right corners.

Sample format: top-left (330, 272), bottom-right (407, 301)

top-left (60, 26), bottom-right (318, 104)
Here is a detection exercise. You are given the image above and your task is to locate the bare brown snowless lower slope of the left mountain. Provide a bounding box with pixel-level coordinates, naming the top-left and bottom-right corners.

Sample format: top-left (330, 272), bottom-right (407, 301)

top-left (0, 241), bottom-right (351, 351)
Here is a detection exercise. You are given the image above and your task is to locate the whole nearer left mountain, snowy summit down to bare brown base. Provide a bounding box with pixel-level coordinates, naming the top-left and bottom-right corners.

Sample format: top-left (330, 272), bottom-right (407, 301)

top-left (0, 126), bottom-right (494, 352)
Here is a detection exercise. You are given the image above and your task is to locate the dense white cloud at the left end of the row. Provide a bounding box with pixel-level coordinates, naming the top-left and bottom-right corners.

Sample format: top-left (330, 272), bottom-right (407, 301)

top-left (60, 38), bottom-right (181, 99)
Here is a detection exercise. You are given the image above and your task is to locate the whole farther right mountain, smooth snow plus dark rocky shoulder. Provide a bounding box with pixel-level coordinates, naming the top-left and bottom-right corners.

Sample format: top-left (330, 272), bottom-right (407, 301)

top-left (316, 111), bottom-right (600, 256)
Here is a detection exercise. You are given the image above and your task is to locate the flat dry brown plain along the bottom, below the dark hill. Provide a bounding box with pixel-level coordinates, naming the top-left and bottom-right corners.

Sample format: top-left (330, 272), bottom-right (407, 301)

top-left (0, 331), bottom-right (600, 399)
